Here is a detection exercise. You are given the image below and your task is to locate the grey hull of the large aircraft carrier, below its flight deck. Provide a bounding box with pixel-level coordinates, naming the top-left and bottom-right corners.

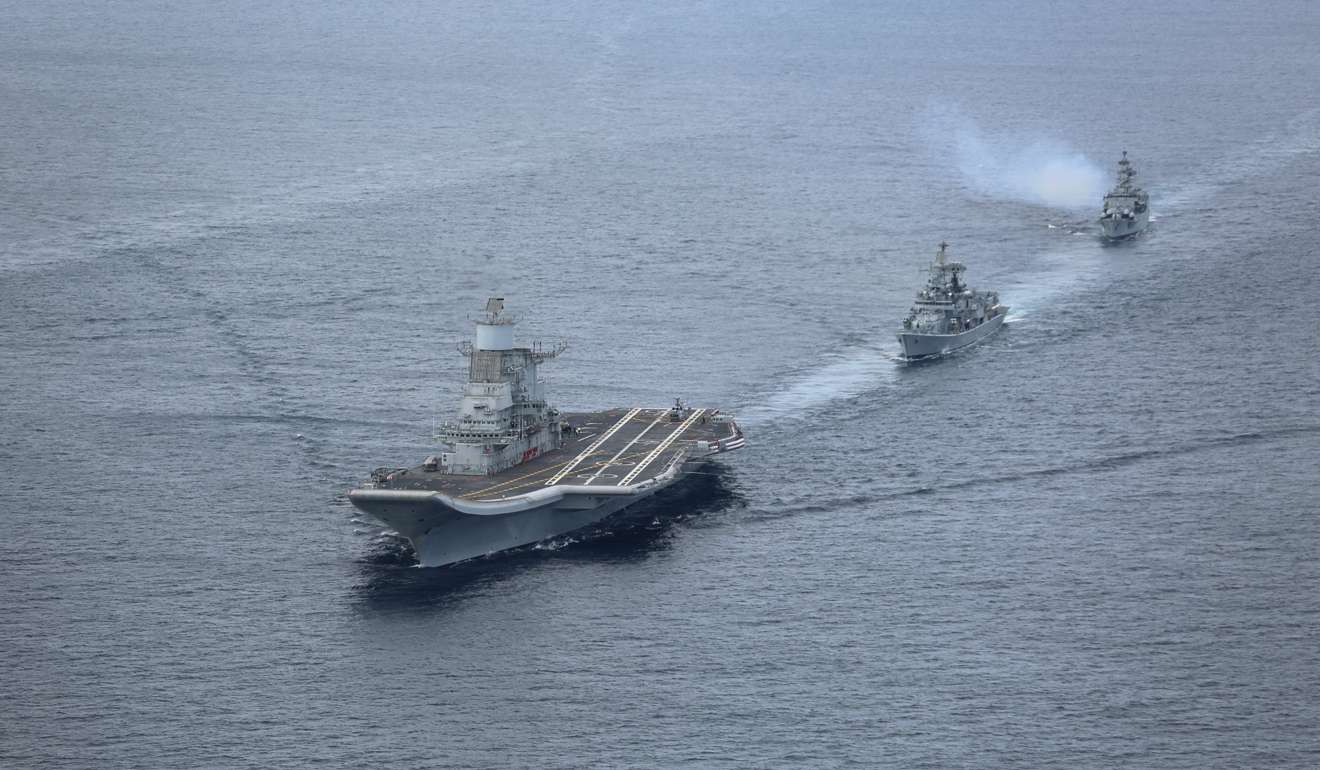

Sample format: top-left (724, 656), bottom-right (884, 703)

top-left (350, 461), bottom-right (701, 567)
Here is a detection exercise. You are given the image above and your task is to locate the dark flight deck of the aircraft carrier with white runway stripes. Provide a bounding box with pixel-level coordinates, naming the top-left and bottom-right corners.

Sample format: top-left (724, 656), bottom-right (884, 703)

top-left (381, 408), bottom-right (735, 501)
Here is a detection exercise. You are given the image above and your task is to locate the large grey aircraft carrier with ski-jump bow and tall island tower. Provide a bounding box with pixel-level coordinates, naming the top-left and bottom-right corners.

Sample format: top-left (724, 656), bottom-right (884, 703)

top-left (348, 297), bottom-right (744, 567)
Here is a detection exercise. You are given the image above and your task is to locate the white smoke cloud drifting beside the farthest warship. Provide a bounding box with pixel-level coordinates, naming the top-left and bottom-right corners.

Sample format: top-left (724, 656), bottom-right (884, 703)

top-left (923, 110), bottom-right (1107, 209)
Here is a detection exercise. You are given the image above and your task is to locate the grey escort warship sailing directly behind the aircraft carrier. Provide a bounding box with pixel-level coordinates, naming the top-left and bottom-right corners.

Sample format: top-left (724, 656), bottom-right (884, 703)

top-left (899, 243), bottom-right (1008, 361)
